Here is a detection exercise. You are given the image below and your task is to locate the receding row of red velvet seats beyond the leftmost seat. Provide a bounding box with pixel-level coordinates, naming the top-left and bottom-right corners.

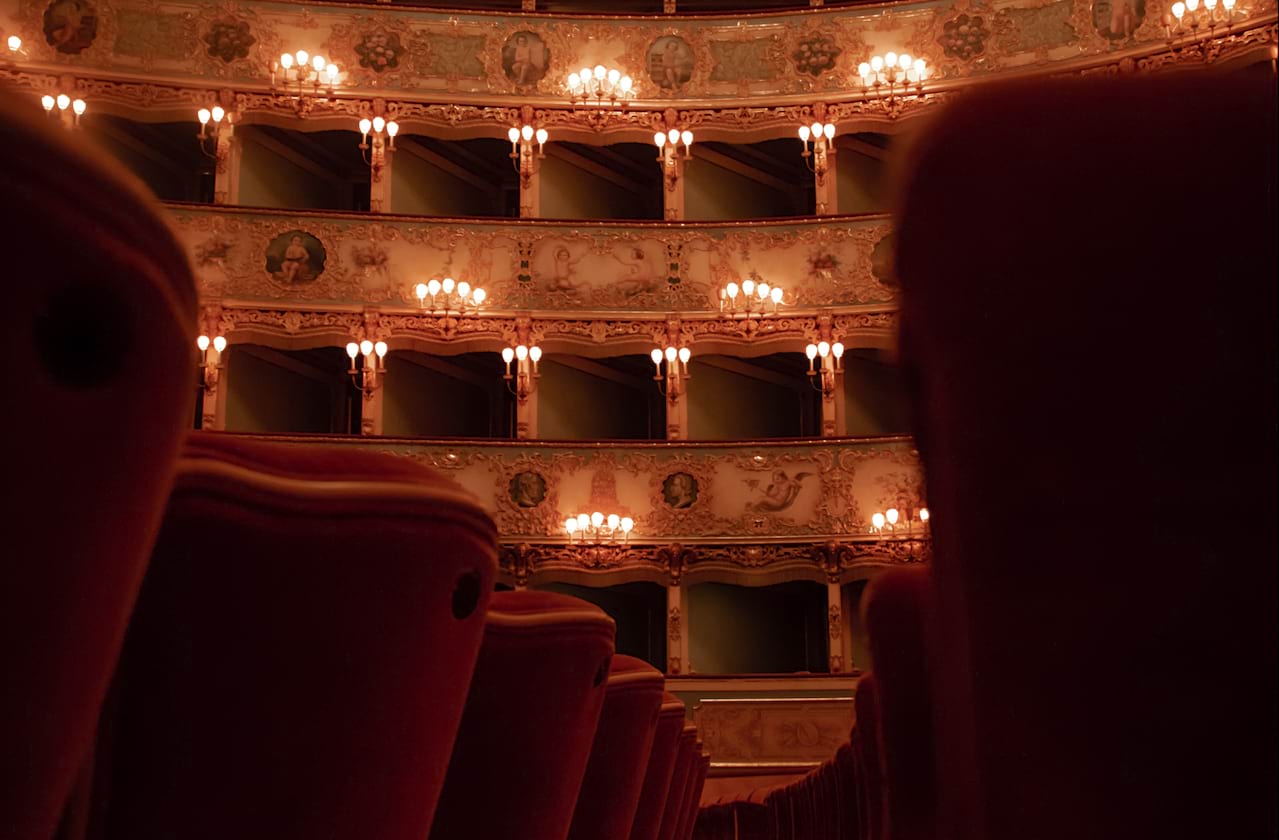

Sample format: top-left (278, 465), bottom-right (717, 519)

top-left (94, 432), bottom-right (721, 840)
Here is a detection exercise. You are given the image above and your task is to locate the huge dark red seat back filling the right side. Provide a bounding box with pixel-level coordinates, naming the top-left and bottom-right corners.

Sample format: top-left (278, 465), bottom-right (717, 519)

top-left (895, 73), bottom-right (1279, 840)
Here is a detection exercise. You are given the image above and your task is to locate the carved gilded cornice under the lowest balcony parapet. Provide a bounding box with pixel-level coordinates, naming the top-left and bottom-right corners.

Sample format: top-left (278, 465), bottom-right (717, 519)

top-left (498, 538), bottom-right (932, 586)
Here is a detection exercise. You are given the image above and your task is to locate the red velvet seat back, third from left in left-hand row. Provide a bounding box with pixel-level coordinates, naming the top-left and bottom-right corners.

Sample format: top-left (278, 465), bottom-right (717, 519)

top-left (430, 592), bottom-right (614, 840)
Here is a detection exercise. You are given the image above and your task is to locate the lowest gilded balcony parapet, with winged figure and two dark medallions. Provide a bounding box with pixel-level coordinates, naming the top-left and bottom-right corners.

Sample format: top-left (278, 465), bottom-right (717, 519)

top-left (249, 436), bottom-right (930, 586)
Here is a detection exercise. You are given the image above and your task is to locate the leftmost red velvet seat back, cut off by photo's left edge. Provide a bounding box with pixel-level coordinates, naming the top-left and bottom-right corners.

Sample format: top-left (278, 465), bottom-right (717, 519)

top-left (0, 93), bottom-right (196, 840)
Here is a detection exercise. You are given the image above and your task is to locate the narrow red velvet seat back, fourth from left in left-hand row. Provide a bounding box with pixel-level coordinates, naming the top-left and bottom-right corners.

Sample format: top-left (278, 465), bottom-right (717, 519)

top-left (568, 655), bottom-right (666, 840)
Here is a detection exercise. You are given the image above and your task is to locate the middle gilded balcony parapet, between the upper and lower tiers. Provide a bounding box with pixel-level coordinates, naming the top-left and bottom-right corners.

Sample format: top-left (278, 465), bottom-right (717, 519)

top-left (177, 205), bottom-right (897, 354)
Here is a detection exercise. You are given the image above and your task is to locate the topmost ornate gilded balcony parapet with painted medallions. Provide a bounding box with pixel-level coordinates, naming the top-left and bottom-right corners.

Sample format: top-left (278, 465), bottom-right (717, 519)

top-left (0, 0), bottom-right (1275, 128)
